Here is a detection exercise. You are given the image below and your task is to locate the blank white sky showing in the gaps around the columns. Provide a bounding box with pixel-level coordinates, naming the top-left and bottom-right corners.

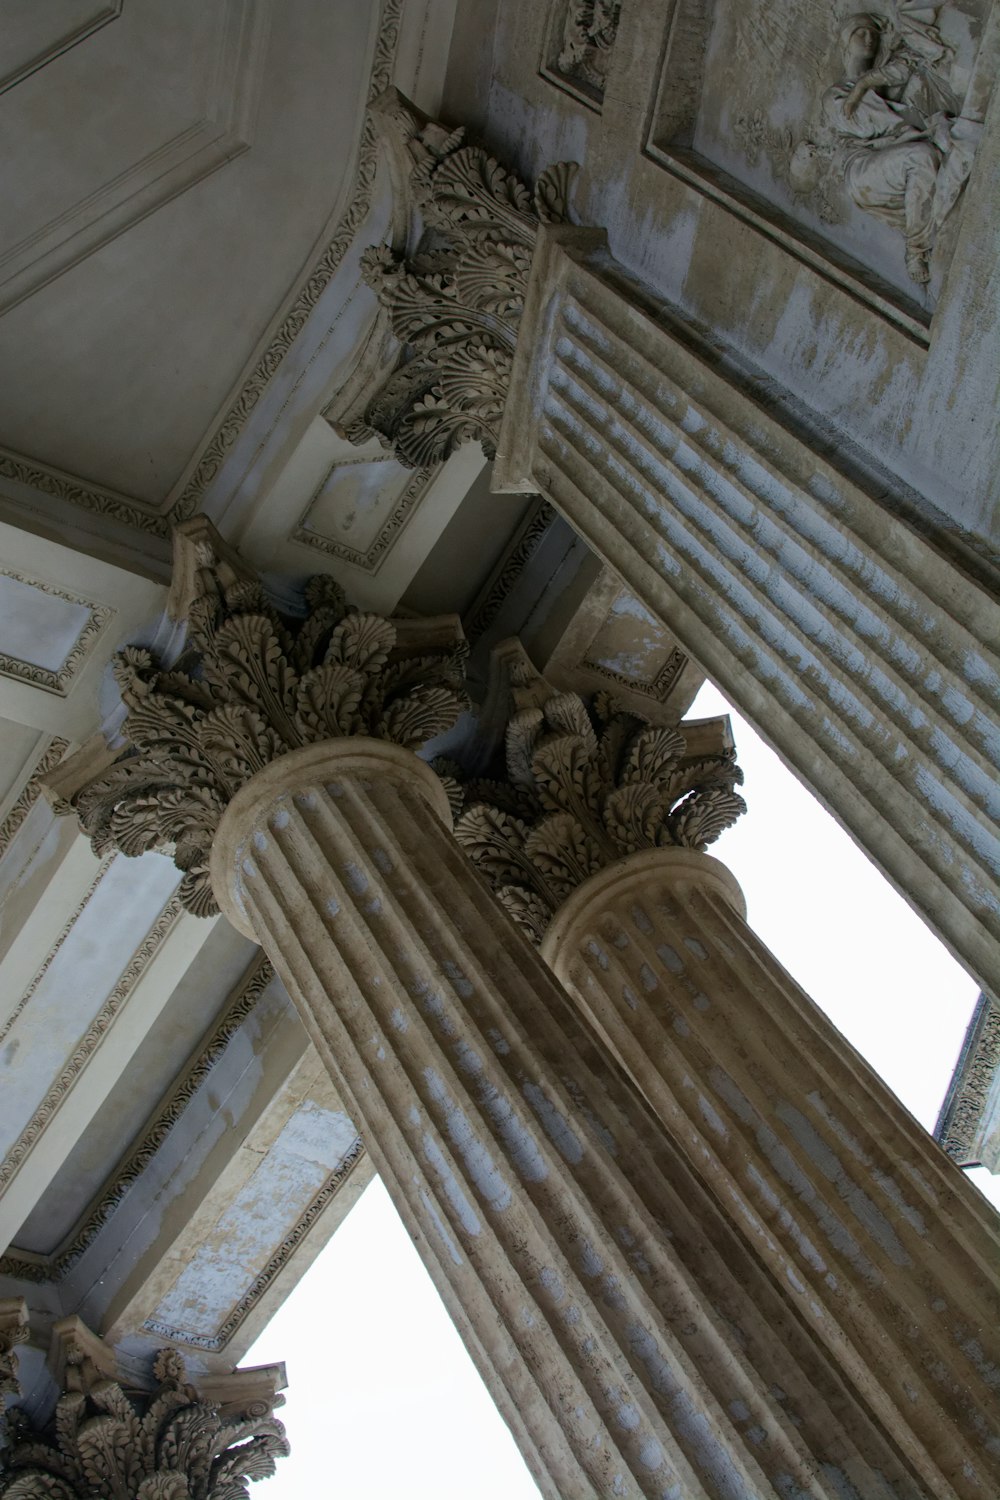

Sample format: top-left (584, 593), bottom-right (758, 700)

top-left (244, 686), bottom-right (1000, 1500)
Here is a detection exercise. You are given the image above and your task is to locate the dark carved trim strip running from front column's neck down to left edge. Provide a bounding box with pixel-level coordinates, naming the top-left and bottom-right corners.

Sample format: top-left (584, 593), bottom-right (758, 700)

top-left (0, 957), bottom-right (274, 1283)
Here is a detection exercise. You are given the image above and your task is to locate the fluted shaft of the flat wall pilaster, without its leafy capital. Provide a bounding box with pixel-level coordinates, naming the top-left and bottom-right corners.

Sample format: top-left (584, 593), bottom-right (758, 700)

top-left (493, 227), bottom-right (1000, 993)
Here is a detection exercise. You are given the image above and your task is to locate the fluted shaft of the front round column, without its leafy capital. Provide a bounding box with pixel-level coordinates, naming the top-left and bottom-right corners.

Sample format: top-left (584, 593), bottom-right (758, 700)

top-left (213, 740), bottom-right (930, 1500)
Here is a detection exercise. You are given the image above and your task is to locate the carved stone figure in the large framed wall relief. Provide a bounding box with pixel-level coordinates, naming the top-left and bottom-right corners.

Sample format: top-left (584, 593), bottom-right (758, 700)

top-left (821, 0), bottom-right (981, 285)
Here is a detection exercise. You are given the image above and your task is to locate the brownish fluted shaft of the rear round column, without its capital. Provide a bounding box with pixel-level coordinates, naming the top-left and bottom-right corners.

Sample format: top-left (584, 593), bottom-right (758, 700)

top-left (543, 849), bottom-right (1000, 1497)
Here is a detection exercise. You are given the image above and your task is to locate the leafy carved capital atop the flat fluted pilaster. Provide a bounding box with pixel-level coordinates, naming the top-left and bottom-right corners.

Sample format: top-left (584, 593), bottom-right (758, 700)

top-left (345, 90), bottom-right (573, 468)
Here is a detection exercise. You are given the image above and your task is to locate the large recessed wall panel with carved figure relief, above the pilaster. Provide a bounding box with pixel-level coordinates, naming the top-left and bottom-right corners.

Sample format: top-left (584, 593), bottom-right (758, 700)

top-left (651, 0), bottom-right (991, 320)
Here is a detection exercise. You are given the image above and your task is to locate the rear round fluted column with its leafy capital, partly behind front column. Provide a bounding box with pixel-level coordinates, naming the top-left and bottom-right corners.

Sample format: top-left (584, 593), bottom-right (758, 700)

top-left (456, 681), bottom-right (1000, 1497)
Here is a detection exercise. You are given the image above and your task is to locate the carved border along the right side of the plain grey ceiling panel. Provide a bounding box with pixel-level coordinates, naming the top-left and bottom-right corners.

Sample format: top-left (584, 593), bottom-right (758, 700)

top-left (169, 0), bottom-right (403, 525)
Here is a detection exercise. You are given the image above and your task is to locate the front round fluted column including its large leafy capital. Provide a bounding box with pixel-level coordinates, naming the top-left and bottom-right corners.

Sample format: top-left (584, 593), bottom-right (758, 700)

top-left (60, 522), bottom-right (930, 1500)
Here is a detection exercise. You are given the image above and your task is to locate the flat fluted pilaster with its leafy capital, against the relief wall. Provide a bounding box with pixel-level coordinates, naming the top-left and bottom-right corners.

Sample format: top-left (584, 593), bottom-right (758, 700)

top-left (341, 92), bottom-right (1000, 995)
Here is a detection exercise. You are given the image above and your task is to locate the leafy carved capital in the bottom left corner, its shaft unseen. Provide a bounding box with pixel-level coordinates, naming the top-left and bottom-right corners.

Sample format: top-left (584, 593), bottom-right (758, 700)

top-left (0, 1350), bottom-right (289, 1500)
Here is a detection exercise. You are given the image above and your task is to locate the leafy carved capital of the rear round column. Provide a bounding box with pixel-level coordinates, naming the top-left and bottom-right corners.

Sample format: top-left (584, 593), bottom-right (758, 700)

top-left (439, 693), bottom-right (745, 942)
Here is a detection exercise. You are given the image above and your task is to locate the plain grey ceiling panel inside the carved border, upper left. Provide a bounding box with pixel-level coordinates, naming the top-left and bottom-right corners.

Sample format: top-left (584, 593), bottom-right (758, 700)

top-left (0, 0), bottom-right (379, 509)
